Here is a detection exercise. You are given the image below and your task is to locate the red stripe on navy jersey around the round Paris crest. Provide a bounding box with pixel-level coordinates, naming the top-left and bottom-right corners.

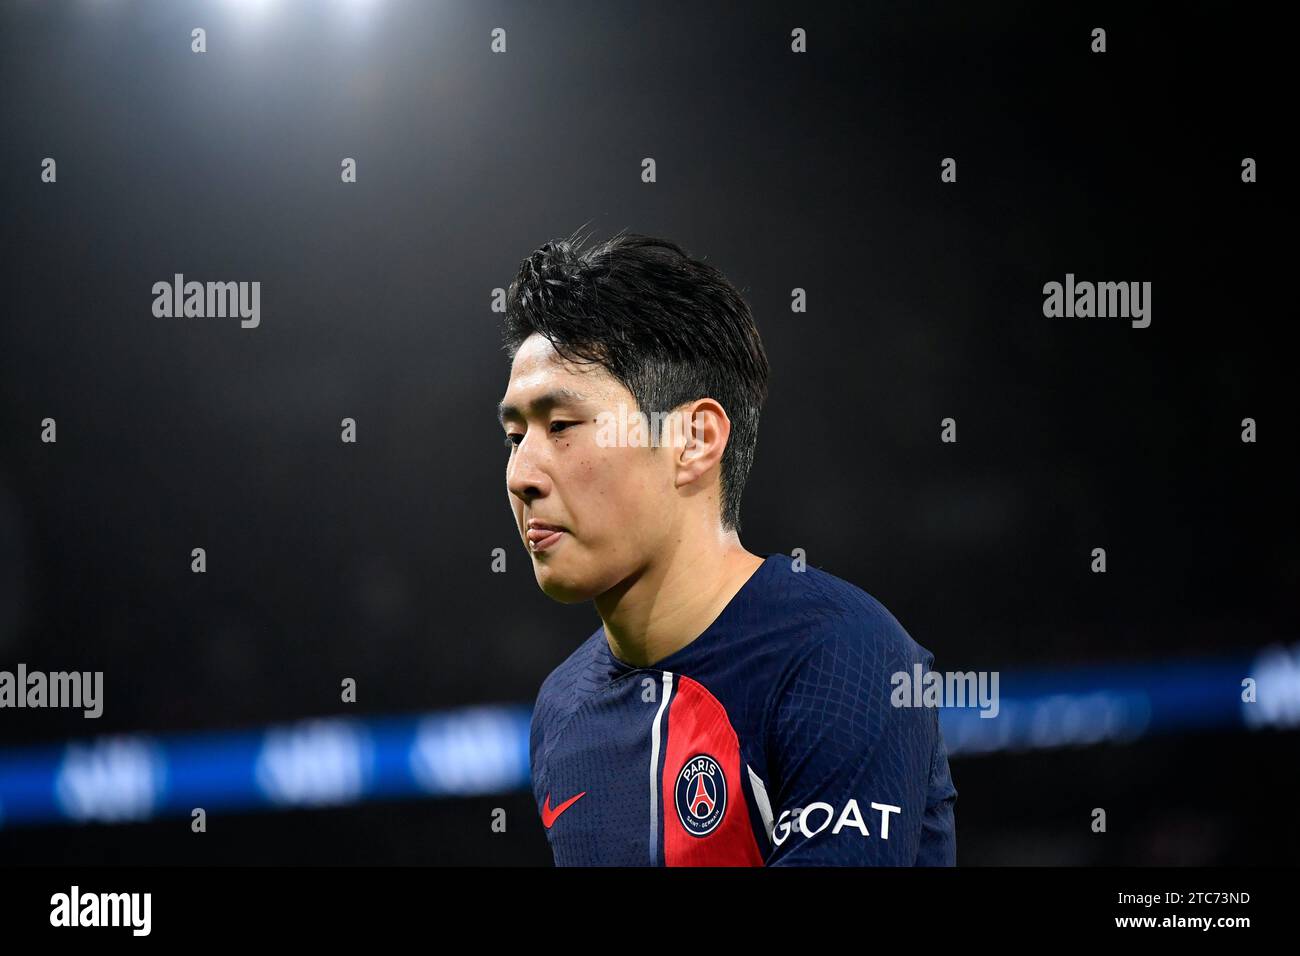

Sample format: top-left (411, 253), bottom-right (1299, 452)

top-left (662, 674), bottom-right (763, 866)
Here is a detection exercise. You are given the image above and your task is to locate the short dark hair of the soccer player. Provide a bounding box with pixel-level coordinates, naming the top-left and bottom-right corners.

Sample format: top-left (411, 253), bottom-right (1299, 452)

top-left (504, 233), bottom-right (767, 533)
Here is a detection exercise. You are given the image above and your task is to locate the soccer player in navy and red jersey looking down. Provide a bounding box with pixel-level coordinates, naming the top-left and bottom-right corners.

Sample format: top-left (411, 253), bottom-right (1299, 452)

top-left (499, 234), bottom-right (957, 866)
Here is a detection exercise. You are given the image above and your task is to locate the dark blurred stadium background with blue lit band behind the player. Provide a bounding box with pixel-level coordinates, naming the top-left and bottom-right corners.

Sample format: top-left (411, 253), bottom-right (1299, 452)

top-left (0, 0), bottom-right (1300, 865)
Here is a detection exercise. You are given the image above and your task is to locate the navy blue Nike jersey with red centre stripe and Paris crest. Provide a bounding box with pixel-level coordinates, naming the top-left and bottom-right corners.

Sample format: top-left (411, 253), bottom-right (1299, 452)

top-left (529, 554), bottom-right (957, 866)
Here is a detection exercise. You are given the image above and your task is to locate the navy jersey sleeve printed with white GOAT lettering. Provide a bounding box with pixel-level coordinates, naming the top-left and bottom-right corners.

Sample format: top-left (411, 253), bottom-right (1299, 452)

top-left (764, 609), bottom-right (956, 866)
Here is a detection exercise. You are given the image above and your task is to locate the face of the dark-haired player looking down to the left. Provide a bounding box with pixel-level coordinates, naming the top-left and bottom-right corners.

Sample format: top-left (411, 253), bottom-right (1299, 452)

top-left (502, 334), bottom-right (677, 604)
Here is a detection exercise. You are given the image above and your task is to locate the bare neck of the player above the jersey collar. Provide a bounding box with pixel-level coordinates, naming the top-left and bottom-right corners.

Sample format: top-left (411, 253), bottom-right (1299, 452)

top-left (595, 531), bottom-right (763, 667)
